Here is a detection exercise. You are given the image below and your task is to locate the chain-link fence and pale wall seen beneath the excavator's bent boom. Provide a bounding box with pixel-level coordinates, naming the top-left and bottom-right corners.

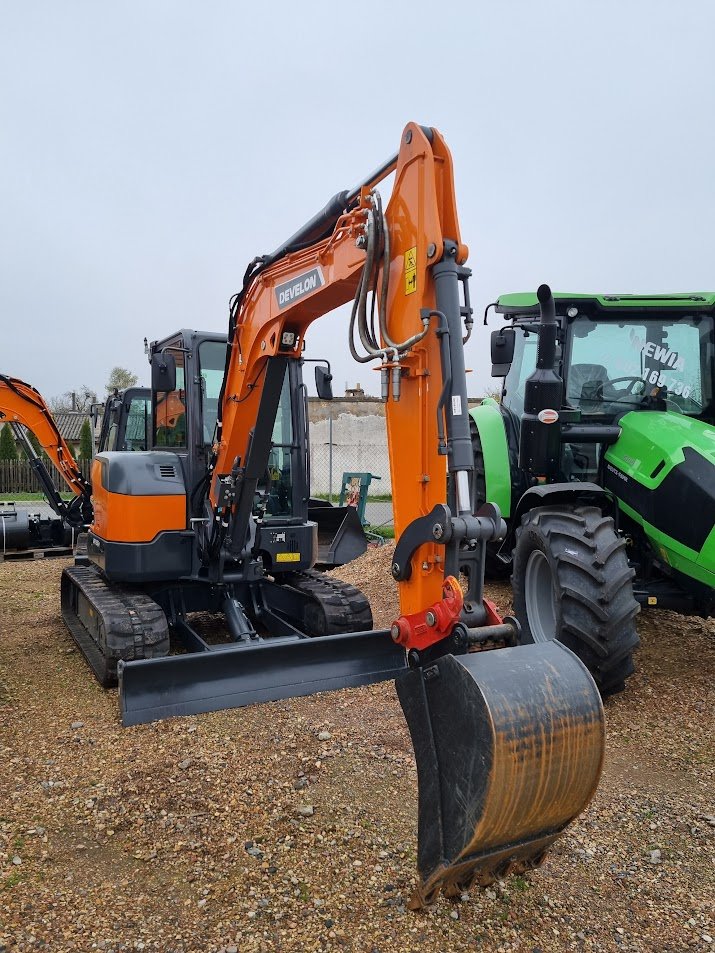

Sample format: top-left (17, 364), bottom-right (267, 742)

top-left (310, 414), bottom-right (392, 530)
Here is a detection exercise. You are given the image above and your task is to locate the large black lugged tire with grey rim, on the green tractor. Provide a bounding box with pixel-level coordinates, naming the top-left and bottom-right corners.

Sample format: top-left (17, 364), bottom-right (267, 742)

top-left (512, 506), bottom-right (640, 698)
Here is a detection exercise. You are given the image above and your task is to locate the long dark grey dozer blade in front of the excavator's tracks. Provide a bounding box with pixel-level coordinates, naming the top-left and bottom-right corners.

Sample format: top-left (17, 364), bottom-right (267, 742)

top-left (118, 630), bottom-right (406, 726)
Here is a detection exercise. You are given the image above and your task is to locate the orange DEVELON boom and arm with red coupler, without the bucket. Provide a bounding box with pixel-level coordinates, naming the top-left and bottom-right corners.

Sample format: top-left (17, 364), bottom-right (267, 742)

top-left (210, 123), bottom-right (501, 648)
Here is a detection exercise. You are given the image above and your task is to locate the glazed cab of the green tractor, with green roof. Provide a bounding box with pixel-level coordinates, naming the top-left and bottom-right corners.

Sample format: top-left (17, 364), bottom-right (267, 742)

top-left (494, 294), bottom-right (715, 481)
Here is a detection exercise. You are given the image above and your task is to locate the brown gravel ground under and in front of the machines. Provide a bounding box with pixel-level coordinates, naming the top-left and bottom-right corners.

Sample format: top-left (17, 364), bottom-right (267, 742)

top-left (0, 547), bottom-right (715, 953)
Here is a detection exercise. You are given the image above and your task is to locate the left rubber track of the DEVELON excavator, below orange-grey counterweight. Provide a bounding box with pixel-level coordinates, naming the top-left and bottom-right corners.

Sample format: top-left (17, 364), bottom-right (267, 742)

top-left (62, 566), bottom-right (169, 687)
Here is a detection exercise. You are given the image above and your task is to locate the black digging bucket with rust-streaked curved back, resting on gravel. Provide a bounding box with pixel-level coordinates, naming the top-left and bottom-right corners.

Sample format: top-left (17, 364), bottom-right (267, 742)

top-left (397, 641), bottom-right (604, 909)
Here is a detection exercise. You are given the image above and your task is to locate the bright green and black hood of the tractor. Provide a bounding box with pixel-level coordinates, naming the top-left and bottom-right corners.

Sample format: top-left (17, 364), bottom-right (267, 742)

top-left (605, 411), bottom-right (715, 587)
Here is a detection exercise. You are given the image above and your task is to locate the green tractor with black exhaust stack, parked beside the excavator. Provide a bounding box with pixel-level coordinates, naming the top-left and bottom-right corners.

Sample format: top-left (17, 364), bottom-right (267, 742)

top-left (471, 285), bottom-right (715, 696)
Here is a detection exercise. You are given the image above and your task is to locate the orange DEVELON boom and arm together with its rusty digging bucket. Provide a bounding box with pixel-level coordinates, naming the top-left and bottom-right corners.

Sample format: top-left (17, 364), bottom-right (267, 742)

top-left (200, 123), bottom-right (603, 907)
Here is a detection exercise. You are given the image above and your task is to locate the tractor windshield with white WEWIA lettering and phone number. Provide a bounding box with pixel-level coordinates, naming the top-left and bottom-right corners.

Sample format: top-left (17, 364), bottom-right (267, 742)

top-left (563, 312), bottom-right (713, 418)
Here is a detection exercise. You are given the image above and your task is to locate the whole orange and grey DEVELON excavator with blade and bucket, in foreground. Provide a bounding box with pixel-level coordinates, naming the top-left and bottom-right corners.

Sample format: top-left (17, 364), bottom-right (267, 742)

top-left (62, 123), bottom-right (604, 907)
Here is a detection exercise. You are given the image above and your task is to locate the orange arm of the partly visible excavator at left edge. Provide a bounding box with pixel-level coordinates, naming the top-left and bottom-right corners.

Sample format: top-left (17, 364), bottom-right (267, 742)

top-left (0, 374), bottom-right (92, 526)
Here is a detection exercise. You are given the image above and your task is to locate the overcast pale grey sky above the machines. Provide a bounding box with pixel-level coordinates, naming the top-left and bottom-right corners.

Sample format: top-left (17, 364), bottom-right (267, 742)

top-left (0, 0), bottom-right (715, 397)
